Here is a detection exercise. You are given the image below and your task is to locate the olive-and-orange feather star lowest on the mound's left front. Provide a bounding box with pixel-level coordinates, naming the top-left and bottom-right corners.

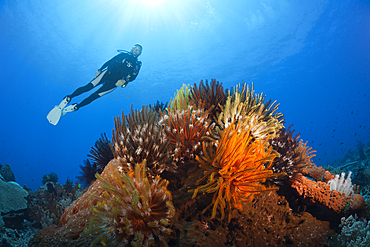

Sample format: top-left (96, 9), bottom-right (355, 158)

top-left (88, 161), bottom-right (175, 246)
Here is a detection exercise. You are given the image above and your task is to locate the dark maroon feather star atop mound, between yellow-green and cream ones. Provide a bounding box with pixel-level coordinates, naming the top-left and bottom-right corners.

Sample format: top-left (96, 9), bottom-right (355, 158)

top-left (190, 79), bottom-right (226, 114)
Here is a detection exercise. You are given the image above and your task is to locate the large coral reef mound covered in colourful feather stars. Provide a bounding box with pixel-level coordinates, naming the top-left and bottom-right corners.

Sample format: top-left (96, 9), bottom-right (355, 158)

top-left (29, 79), bottom-right (370, 247)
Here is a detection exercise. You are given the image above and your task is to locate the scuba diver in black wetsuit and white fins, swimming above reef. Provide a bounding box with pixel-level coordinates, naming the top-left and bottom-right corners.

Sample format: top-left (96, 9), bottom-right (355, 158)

top-left (47, 44), bottom-right (143, 125)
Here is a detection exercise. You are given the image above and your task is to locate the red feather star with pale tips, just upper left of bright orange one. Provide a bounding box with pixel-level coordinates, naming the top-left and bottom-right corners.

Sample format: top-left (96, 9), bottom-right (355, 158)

top-left (160, 105), bottom-right (214, 167)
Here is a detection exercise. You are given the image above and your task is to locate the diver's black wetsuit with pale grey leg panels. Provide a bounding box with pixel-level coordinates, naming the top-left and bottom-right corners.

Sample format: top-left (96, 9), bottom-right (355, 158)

top-left (68, 52), bottom-right (141, 110)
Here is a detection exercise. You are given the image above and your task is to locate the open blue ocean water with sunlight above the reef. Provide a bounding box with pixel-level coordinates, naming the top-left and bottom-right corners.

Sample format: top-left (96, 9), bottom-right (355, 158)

top-left (0, 0), bottom-right (370, 190)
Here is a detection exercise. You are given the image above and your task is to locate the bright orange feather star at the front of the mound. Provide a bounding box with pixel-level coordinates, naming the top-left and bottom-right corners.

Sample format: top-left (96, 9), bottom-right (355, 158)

top-left (193, 124), bottom-right (277, 222)
